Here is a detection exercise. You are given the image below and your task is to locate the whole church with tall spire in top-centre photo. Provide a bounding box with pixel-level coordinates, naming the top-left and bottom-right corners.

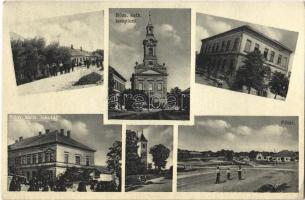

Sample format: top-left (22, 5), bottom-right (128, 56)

top-left (130, 13), bottom-right (168, 102)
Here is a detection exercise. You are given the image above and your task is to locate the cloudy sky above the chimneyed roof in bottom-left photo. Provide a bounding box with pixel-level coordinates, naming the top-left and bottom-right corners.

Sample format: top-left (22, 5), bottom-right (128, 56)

top-left (8, 115), bottom-right (122, 166)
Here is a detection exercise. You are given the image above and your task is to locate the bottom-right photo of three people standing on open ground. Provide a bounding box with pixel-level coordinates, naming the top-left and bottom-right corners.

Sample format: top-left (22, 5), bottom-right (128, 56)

top-left (177, 116), bottom-right (299, 193)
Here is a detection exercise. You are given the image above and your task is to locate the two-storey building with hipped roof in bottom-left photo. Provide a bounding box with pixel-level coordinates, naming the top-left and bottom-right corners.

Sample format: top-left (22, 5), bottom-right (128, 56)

top-left (8, 129), bottom-right (95, 180)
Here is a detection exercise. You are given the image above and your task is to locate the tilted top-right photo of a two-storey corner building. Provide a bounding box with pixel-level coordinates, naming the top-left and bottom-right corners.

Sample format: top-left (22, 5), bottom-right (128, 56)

top-left (195, 13), bottom-right (298, 100)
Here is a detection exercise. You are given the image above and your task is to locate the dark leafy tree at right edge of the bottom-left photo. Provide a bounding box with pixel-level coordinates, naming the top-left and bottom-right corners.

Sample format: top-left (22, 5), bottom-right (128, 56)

top-left (107, 141), bottom-right (122, 191)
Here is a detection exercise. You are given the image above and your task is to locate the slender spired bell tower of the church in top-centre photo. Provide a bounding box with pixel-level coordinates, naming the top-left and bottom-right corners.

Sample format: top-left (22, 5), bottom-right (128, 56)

top-left (143, 11), bottom-right (157, 67)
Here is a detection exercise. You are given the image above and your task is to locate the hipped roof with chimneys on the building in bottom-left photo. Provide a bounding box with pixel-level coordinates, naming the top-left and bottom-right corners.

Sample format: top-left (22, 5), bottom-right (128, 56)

top-left (8, 129), bottom-right (96, 152)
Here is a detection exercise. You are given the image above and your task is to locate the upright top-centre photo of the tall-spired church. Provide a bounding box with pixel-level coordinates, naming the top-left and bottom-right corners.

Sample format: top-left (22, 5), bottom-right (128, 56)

top-left (108, 8), bottom-right (191, 120)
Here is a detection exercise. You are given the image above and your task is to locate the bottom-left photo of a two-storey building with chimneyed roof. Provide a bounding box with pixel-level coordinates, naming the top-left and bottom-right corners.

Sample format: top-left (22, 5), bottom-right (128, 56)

top-left (7, 114), bottom-right (122, 192)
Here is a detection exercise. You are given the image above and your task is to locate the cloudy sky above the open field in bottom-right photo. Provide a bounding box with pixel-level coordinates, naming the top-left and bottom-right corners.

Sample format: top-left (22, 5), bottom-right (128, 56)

top-left (178, 116), bottom-right (298, 152)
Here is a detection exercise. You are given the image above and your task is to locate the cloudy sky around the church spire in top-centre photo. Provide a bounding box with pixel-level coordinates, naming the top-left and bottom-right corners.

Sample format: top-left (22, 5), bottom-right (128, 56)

top-left (109, 9), bottom-right (191, 90)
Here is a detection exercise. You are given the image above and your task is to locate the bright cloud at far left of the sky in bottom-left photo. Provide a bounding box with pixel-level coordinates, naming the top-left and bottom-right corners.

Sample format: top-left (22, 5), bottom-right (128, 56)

top-left (8, 119), bottom-right (45, 140)
